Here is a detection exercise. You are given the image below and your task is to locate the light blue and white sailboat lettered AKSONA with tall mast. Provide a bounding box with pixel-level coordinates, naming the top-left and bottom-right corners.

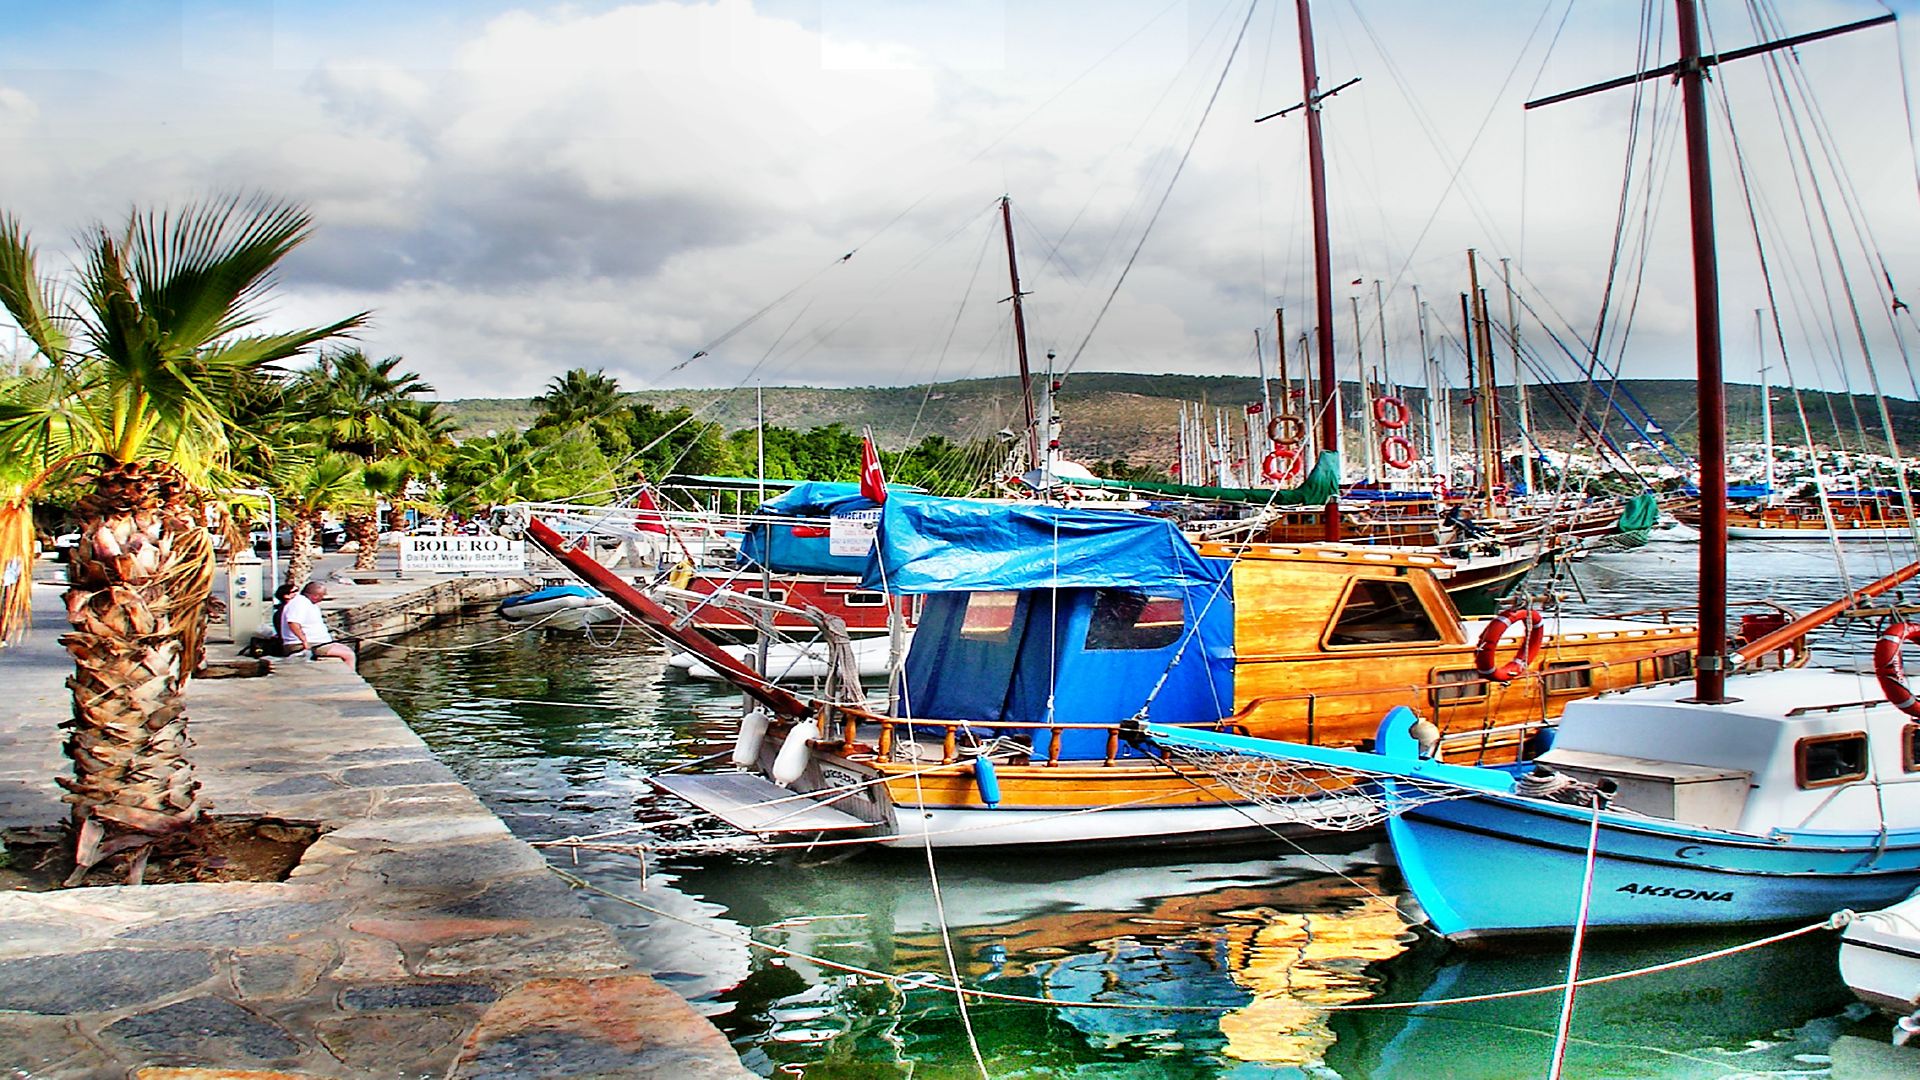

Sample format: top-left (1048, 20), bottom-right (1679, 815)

top-left (1144, 0), bottom-right (1920, 940)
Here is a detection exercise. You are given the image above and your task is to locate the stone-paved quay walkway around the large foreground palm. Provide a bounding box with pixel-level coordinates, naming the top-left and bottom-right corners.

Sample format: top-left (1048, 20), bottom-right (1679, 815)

top-left (0, 557), bottom-right (753, 1080)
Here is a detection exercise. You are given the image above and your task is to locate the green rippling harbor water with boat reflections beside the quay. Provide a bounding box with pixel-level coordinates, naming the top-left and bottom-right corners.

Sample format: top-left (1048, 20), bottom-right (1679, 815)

top-left (363, 544), bottom-right (1920, 1080)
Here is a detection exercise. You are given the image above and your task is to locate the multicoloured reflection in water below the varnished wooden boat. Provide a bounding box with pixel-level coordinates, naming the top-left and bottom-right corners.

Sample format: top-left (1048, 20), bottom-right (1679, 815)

top-left (676, 847), bottom-right (1405, 1076)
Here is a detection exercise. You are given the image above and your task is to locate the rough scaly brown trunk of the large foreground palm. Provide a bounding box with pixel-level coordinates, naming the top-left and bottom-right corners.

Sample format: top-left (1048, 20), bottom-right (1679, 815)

top-left (58, 461), bottom-right (213, 884)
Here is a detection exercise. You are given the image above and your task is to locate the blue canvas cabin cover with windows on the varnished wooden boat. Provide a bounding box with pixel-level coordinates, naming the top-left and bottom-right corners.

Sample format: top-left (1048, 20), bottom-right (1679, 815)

top-left (862, 496), bottom-right (1233, 759)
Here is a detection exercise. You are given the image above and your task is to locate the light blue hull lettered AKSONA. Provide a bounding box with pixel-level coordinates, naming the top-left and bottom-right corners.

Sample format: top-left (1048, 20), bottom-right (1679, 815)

top-left (1388, 796), bottom-right (1920, 940)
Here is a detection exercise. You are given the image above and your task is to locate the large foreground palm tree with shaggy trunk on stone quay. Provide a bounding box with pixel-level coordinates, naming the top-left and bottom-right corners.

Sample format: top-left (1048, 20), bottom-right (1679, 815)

top-left (0, 196), bottom-right (365, 882)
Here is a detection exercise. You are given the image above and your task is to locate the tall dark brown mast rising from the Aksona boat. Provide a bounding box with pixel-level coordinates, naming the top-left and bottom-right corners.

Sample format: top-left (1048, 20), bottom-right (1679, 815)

top-left (1674, 0), bottom-right (1728, 703)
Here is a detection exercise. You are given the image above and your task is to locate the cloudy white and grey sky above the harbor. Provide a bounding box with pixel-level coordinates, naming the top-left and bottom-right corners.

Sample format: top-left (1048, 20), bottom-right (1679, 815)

top-left (0, 0), bottom-right (1920, 398)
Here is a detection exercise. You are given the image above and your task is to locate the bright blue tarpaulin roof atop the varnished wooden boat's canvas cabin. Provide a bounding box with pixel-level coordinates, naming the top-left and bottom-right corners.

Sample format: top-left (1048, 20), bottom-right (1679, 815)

top-left (862, 496), bottom-right (1227, 594)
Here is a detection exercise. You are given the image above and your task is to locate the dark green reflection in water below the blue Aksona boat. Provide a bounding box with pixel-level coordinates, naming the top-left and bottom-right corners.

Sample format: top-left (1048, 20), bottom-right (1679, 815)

top-left (1325, 914), bottom-right (1847, 1080)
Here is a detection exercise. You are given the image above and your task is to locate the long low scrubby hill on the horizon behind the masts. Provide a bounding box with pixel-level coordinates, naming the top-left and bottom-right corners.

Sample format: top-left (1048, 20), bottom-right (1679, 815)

top-left (445, 371), bottom-right (1920, 467)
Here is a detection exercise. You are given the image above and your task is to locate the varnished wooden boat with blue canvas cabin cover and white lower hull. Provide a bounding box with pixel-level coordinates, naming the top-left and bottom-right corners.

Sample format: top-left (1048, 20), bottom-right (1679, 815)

top-left (510, 496), bottom-right (1695, 847)
